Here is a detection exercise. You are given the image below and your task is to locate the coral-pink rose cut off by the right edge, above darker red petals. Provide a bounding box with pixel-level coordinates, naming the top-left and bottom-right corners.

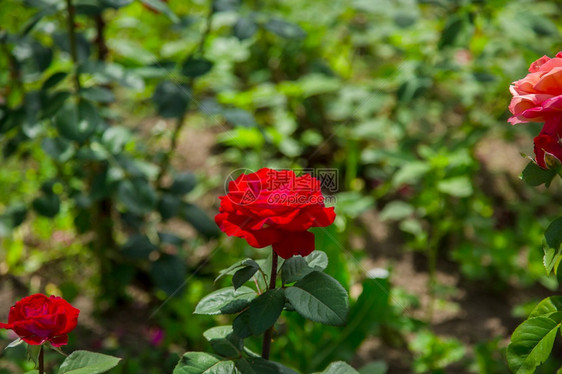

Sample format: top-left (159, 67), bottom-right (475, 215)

top-left (508, 52), bottom-right (562, 127)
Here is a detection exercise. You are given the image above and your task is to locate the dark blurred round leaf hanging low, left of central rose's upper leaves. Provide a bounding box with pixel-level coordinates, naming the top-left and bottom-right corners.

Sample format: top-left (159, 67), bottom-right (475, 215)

top-left (150, 254), bottom-right (187, 295)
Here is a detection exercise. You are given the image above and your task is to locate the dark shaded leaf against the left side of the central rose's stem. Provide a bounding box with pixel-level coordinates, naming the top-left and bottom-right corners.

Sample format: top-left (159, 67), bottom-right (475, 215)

top-left (248, 288), bottom-right (285, 335)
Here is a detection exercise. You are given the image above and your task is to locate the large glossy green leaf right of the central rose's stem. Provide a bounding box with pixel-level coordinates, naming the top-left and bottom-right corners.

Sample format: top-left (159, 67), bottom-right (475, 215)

top-left (285, 271), bottom-right (349, 326)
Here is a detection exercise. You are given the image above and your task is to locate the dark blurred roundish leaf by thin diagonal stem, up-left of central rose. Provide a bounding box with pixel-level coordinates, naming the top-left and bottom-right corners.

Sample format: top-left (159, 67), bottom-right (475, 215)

top-left (152, 80), bottom-right (191, 118)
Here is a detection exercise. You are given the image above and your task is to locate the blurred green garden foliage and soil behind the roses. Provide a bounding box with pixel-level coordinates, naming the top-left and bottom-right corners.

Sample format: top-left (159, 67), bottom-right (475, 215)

top-left (0, 0), bottom-right (562, 374)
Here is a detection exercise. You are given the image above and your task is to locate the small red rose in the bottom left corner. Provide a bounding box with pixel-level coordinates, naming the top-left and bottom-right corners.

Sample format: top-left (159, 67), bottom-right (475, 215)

top-left (0, 293), bottom-right (80, 347)
